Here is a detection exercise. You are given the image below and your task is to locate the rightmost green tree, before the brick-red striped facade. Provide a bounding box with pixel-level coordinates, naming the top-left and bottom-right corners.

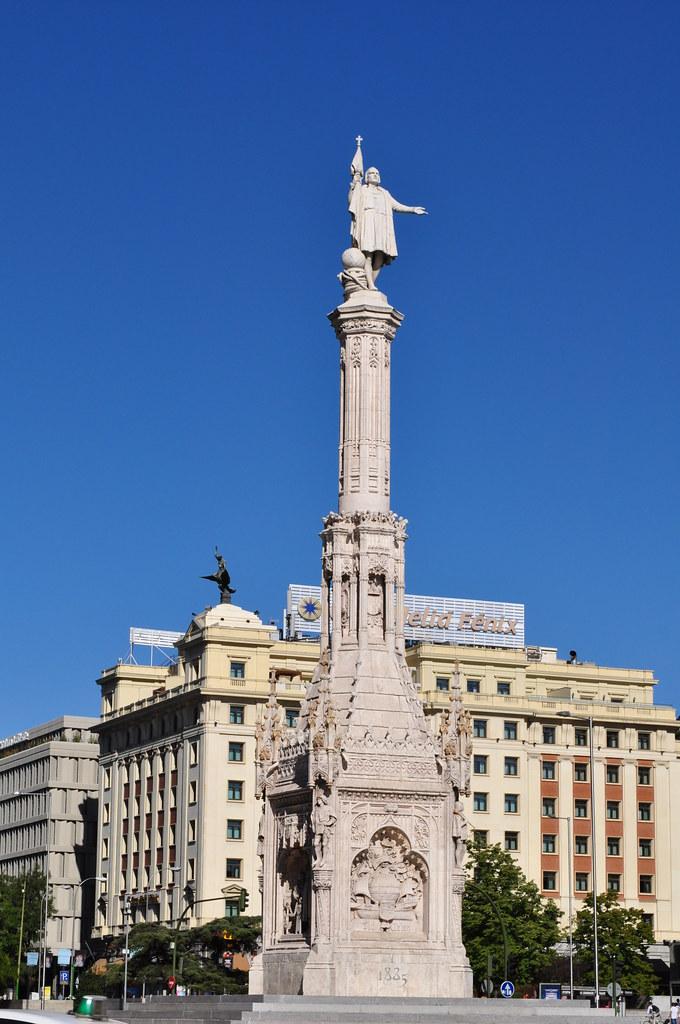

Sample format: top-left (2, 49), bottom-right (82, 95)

top-left (573, 892), bottom-right (657, 995)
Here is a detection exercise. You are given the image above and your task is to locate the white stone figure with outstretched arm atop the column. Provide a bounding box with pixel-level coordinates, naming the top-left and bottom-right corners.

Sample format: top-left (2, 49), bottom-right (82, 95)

top-left (350, 135), bottom-right (427, 289)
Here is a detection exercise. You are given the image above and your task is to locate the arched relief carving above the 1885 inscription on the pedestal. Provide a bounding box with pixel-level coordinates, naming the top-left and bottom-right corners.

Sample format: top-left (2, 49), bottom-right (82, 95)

top-left (350, 827), bottom-right (428, 932)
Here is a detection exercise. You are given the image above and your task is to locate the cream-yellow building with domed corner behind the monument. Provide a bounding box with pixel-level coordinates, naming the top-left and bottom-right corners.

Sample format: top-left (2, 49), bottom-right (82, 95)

top-left (95, 604), bottom-right (680, 941)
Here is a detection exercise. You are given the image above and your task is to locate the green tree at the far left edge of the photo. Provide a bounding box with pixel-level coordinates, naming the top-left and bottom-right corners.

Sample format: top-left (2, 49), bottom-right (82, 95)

top-left (0, 871), bottom-right (51, 989)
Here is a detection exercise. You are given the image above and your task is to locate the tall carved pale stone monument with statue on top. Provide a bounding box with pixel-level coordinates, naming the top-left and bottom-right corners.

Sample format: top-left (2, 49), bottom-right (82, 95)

top-left (251, 128), bottom-right (472, 996)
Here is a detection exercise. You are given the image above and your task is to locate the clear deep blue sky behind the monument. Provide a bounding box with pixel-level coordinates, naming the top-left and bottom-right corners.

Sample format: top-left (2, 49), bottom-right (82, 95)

top-left (0, 0), bottom-right (680, 735)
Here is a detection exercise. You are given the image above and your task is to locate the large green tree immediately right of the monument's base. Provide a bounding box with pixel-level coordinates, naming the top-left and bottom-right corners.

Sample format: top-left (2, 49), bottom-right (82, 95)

top-left (463, 843), bottom-right (561, 985)
